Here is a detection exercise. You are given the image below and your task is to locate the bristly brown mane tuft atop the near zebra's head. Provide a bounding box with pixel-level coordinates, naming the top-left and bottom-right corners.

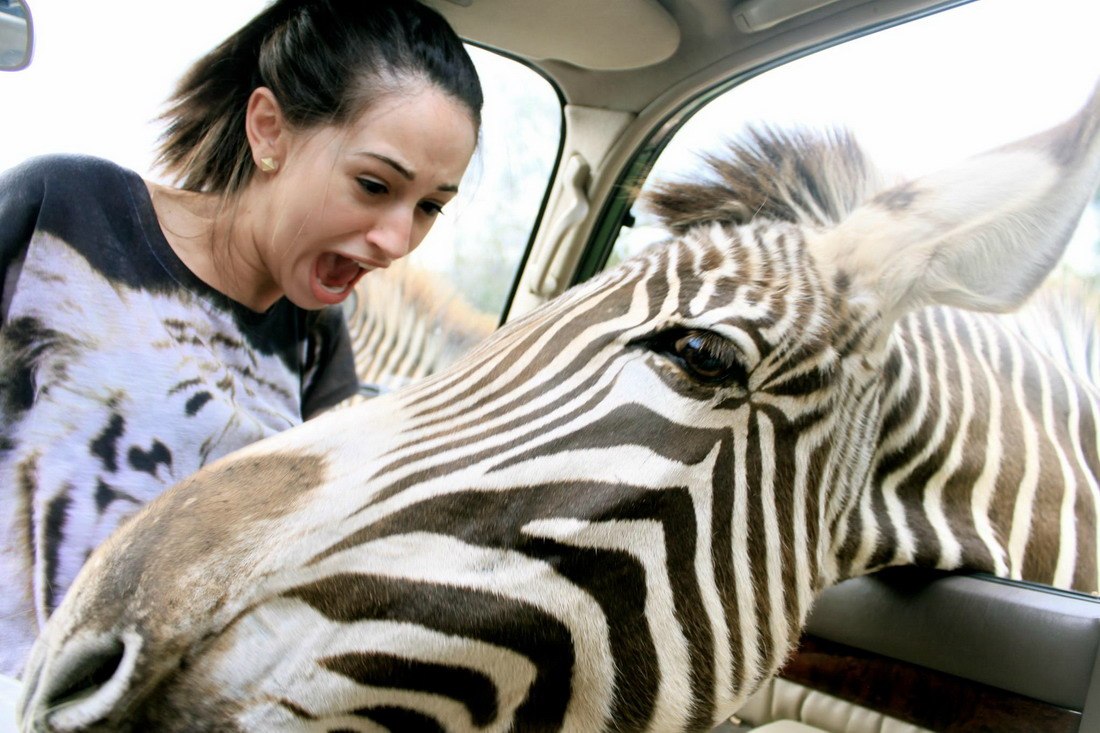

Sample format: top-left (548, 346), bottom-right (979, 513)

top-left (644, 125), bottom-right (883, 232)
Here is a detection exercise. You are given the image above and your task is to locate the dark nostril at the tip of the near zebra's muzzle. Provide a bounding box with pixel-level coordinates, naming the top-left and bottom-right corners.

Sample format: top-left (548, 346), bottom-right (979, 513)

top-left (34, 634), bottom-right (142, 731)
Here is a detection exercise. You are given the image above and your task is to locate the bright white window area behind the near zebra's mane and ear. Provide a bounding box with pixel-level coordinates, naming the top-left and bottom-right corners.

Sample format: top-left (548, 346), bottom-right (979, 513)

top-left (611, 0), bottom-right (1100, 276)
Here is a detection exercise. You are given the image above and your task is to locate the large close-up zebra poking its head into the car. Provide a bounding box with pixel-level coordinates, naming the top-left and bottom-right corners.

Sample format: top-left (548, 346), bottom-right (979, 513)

top-left (21, 81), bottom-right (1100, 732)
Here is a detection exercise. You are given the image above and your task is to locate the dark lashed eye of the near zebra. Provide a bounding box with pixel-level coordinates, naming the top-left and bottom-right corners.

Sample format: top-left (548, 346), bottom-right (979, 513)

top-left (630, 328), bottom-right (749, 390)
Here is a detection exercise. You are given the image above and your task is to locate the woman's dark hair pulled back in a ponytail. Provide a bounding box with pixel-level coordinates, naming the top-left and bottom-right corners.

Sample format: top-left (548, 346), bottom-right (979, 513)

top-left (157, 0), bottom-right (482, 193)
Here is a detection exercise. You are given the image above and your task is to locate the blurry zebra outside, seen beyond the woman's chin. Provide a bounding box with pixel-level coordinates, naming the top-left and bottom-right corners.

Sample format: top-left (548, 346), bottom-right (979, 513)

top-left (342, 260), bottom-right (497, 406)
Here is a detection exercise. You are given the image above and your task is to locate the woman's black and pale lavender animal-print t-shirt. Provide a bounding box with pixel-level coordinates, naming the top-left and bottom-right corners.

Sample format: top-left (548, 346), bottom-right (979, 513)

top-left (0, 156), bottom-right (355, 675)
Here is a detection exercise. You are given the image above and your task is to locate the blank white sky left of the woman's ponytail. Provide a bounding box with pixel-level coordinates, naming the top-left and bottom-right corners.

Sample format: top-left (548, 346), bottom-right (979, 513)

top-left (0, 0), bottom-right (266, 173)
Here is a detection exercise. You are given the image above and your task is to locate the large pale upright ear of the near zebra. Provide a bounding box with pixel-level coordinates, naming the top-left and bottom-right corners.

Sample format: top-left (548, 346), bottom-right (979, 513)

top-left (810, 77), bottom-right (1100, 322)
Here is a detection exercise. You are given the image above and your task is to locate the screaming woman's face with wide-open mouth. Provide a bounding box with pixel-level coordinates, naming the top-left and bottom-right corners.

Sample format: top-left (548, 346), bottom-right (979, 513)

top-left (252, 86), bottom-right (477, 309)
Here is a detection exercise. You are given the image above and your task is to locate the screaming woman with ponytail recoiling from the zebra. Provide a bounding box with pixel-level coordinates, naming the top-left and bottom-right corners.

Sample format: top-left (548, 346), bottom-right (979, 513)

top-left (0, 0), bottom-right (482, 675)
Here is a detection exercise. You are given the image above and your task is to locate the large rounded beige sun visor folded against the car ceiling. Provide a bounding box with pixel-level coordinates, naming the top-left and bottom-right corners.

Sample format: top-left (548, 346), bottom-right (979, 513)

top-left (424, 0), bottom-right (680, 70)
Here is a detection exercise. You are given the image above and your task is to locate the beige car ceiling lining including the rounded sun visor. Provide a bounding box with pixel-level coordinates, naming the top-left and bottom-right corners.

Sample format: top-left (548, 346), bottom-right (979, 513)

top-left (425, 0), bottom-right (966, 112)
